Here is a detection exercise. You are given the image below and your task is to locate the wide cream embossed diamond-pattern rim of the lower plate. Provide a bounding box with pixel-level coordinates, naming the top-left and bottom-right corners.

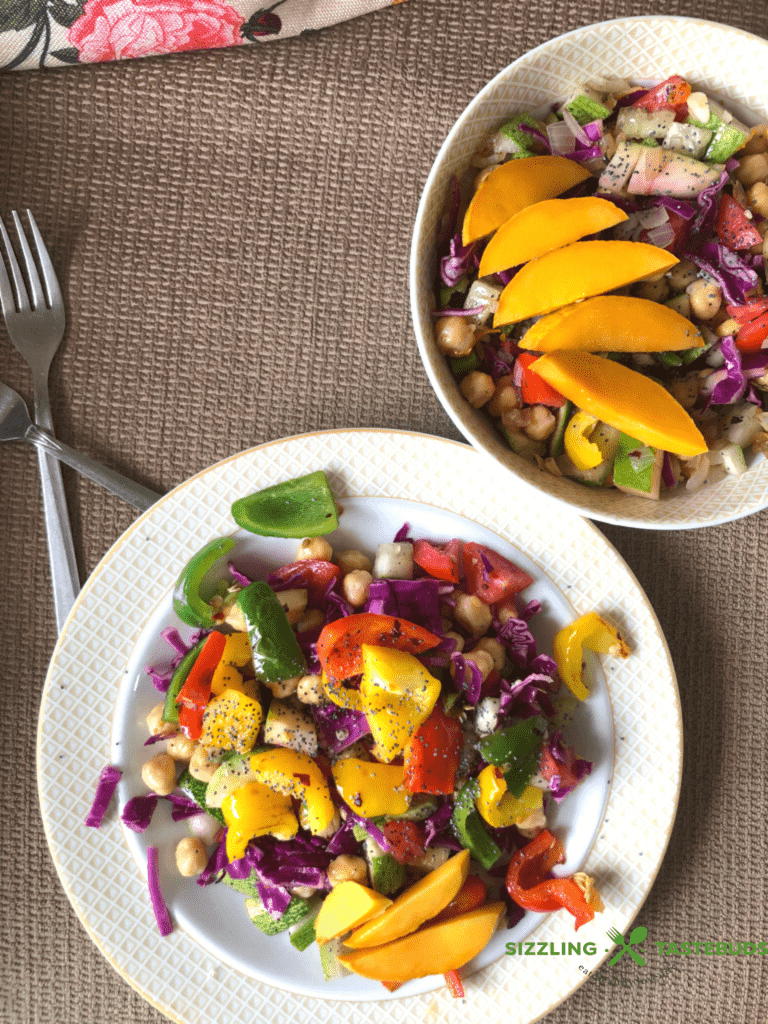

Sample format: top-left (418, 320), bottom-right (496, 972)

top-left (38, 430), bottom-right (682, 1024)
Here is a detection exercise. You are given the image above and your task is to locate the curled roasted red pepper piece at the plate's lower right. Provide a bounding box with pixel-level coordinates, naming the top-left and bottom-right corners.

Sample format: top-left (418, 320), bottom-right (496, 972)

top-left (506, 828), bottom-right (595, 930)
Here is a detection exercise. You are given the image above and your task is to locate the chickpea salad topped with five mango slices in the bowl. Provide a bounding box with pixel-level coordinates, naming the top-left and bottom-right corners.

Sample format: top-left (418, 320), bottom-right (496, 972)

top-left (434, 75), bottom-right (768, 499)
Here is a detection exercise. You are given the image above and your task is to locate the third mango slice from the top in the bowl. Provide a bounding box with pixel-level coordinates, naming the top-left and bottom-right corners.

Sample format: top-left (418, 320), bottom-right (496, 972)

top-left (494, 242), bottom-right (678, 327)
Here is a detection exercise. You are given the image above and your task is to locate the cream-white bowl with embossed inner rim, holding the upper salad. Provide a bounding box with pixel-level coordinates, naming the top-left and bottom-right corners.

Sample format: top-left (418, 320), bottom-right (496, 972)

top-left (411, 16), bottom-right (768, 529)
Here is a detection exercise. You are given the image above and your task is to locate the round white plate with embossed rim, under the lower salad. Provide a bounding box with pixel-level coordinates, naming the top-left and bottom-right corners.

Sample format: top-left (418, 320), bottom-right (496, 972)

top-left (38, 430), bottom-right (682, 1024)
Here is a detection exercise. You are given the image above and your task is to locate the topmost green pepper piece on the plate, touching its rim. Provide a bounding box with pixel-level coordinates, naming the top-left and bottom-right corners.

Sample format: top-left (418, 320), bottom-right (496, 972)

top-left (232, 469), bottom-right (339, 537)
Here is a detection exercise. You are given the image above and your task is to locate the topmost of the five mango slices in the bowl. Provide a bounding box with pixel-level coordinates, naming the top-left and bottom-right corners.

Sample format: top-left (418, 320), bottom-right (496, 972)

top-left (462, 157), bottom-right (590, 246)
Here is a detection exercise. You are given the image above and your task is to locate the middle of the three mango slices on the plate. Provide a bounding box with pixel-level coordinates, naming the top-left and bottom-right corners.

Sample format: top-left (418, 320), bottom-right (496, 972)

top-left (344, 850), bottom-right (469, 949)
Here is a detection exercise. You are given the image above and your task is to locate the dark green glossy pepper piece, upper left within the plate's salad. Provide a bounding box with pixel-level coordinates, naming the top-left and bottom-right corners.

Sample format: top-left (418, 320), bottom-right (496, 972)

top-left (234, 580), bottom-right (306, 682)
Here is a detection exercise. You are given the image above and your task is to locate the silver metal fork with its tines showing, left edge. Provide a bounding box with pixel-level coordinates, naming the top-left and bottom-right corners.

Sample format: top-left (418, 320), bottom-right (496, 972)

top-left (0, 210), bottom-right (80, 632)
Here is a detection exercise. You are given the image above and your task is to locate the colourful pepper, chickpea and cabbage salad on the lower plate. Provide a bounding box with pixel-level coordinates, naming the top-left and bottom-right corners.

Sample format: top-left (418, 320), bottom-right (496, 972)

top-left (88, 473), bottom-right (629, 994)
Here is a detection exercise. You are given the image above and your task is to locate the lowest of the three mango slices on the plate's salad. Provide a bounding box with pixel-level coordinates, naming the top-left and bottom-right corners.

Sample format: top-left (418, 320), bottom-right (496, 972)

top-left (339, 903), bottom-right (504, 981)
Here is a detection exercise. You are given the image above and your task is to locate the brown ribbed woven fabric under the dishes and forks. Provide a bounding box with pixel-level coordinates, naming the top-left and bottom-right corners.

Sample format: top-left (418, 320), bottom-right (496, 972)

top-left (0, 0), bottom-right (768, 1024)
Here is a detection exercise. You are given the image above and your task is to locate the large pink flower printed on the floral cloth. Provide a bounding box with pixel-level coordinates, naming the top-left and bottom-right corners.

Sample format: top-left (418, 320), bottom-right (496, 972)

top-left (69, 0), bottom-right (243, 63)
